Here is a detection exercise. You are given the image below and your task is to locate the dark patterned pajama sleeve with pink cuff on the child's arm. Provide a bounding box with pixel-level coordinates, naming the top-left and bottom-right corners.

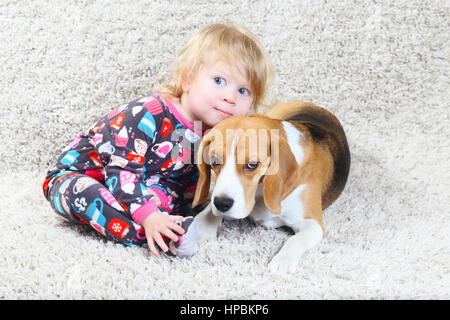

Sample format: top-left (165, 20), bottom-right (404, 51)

top-left (93, 100), bottom-right (171, 224)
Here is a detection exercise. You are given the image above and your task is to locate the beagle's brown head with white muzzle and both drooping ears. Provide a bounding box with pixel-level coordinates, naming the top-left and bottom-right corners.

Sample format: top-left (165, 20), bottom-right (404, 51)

top-left (193, 115), bottom-right (298, 219)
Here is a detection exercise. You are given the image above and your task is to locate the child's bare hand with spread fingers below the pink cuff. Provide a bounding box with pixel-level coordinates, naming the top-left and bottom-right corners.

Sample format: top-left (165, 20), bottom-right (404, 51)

top-left (141, 212), bottom-right (184, 256)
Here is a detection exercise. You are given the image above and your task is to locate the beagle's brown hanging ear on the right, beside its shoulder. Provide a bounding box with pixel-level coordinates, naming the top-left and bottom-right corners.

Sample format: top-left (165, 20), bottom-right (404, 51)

top-left (263, 137), bottom-right (297, 214)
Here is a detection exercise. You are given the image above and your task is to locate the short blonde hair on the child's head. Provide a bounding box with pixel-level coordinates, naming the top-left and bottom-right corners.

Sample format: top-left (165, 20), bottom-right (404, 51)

top-left (158, 24), bottom-right (274, 111)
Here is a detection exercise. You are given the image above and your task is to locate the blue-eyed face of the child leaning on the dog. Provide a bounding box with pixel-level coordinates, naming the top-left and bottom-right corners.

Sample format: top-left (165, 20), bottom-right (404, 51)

top-left (181, 56), bottom-right (253, 127)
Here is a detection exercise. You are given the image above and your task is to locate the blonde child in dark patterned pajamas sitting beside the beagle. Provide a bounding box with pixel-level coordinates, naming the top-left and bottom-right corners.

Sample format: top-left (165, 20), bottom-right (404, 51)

top-left (43, 24), bottom-right (273, 256)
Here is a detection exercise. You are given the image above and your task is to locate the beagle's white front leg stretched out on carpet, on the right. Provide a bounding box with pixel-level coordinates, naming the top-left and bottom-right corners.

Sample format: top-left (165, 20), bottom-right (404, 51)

top-left (269, 219), bottom-right (323, 274)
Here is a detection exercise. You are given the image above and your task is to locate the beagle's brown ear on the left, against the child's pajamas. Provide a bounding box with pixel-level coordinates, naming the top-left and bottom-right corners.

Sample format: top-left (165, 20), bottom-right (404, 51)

top-left (192, 134), bottom-right (211, 207)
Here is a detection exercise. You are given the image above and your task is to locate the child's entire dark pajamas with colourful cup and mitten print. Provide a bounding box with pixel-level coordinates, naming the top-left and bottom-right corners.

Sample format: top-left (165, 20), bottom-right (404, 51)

top-left (43, 94), bottom-right (202, 246)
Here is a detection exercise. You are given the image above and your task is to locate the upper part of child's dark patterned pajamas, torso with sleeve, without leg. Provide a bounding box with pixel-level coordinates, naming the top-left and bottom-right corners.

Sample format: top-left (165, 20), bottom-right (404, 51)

top-left (44, 93), bottom-right (202, 224)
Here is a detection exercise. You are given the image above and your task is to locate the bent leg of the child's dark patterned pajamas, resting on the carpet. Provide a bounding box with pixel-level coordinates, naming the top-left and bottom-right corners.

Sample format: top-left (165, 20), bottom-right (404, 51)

top-left (47, 172), bottom-right (147, 247)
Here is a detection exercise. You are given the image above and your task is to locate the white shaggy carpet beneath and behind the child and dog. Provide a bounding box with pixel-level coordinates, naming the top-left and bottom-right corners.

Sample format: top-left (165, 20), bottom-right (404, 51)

top-left (0, 0), bottom-right (450, 299)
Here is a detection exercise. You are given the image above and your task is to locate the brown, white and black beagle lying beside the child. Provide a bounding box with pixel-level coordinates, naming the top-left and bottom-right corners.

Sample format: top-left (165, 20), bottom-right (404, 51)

top-left (193, 101), bottom-right (350, 273)
